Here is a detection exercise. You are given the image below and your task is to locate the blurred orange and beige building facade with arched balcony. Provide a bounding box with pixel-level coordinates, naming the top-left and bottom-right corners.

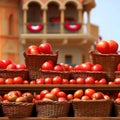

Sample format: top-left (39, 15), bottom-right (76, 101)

top-left (0, 0), bottom-right (99, 65)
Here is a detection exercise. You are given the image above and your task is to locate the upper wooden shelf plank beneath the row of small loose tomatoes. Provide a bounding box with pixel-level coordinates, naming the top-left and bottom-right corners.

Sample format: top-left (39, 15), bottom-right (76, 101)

top-left (0, 84), bottom-right (120, 91)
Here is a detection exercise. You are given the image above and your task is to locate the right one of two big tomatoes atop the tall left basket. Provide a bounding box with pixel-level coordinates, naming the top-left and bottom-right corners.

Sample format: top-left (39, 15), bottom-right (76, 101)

top-left (39, 43), bottom-right (53, 54)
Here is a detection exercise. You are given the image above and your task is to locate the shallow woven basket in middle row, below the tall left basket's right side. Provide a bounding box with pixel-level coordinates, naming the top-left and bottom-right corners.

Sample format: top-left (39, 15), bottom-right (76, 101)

top-left (39, 70), bottom-right (71, 80)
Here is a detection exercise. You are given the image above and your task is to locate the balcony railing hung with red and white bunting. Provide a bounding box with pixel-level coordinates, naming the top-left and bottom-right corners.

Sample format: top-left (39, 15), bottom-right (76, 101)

top-left (21, 22), bottom-right (98, 37)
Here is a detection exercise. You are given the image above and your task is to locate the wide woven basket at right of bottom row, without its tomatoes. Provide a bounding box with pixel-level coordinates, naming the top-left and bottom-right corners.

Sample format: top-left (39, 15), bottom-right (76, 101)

top-left (71, 100), bottom-right (112, 117)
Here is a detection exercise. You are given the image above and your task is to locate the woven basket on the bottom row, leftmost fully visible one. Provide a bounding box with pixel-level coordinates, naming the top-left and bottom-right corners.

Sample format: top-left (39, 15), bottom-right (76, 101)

top-left (2, 102), bottom-right (34, 117)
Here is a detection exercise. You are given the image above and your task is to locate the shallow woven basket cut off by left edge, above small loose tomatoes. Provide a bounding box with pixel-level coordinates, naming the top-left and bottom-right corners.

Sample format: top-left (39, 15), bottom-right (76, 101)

top-left (0, 69), bottom-right (29, 80)
